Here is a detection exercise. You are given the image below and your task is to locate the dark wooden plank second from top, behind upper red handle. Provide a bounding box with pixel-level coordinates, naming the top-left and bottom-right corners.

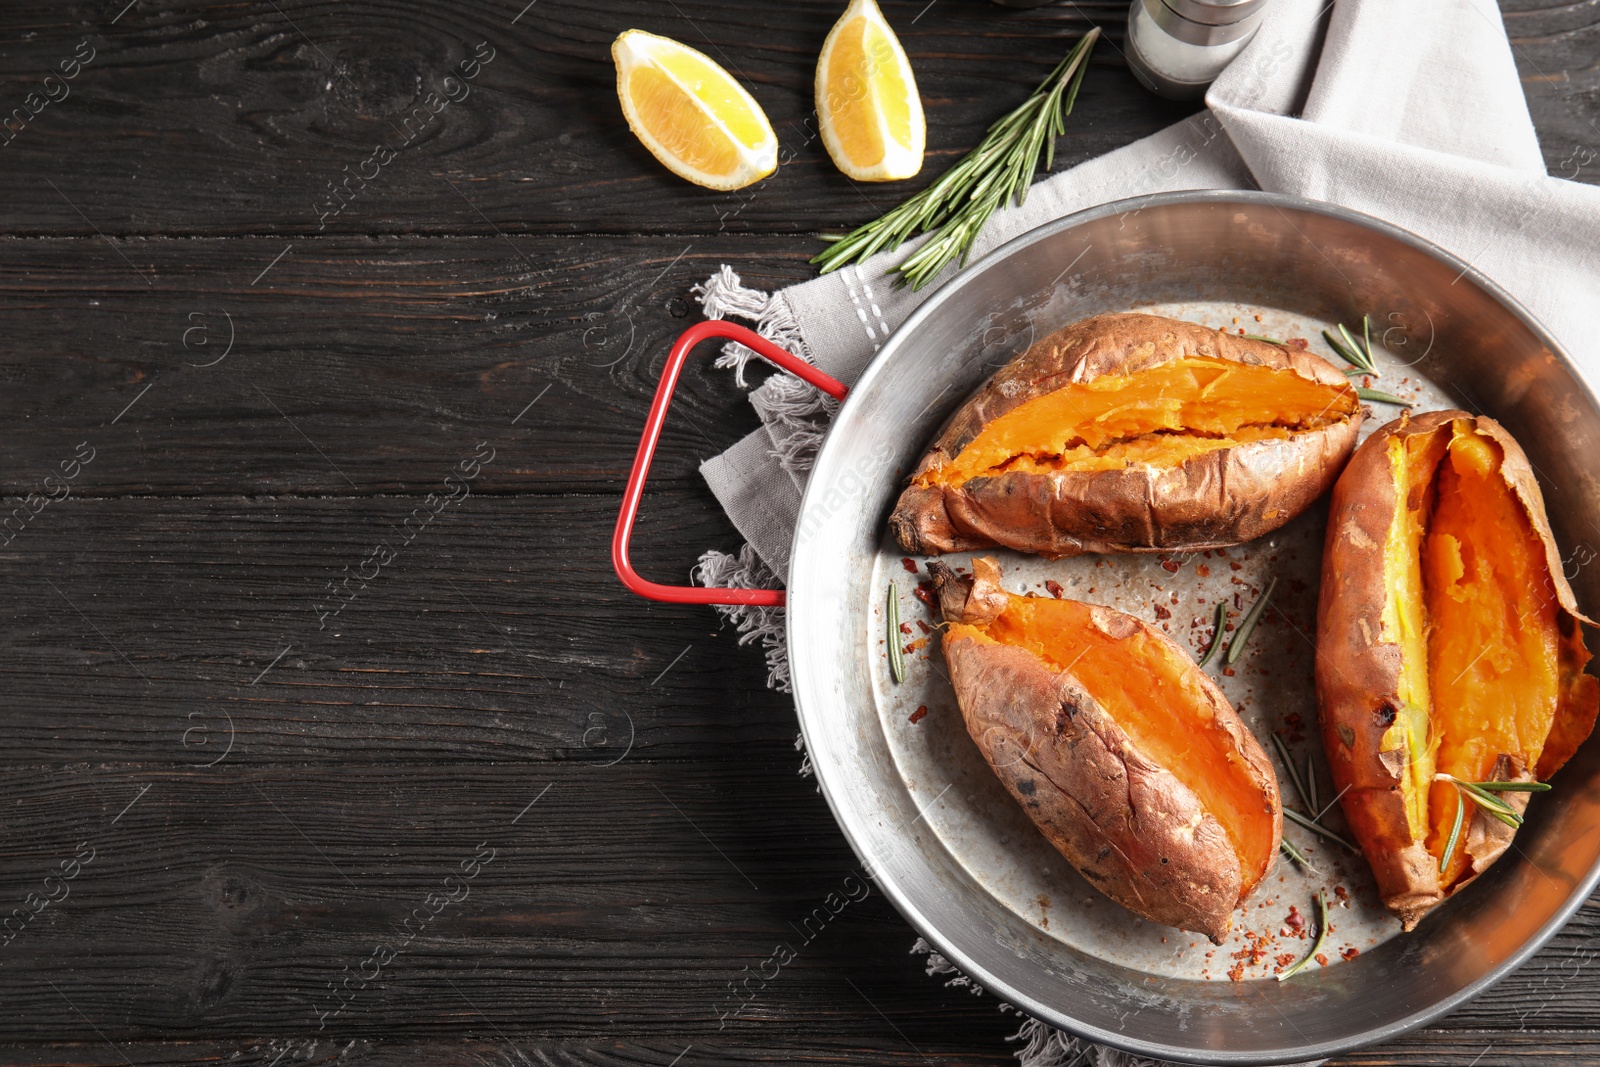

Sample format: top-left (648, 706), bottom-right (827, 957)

top-left (0, 237), bottom-right (811, 495)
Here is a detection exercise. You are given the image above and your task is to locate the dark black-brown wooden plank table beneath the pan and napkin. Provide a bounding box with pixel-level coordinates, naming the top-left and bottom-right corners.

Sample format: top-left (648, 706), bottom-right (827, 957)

top-left (0, 0), bottom-right (1600, 1067)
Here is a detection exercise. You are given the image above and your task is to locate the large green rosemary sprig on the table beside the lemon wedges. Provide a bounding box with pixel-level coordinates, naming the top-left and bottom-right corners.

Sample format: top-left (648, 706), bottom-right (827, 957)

top-left (811, 29), bottom-right (1099, 290)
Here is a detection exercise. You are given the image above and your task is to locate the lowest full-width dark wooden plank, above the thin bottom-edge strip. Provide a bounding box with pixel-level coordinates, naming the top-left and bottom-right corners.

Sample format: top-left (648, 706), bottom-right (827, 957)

top-left (0, 767), bottom-right (1013, 1053)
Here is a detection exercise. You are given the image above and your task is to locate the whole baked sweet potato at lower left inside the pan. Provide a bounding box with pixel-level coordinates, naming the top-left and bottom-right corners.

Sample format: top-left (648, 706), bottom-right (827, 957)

top-left (933, 558), bottom-right (1283, 944)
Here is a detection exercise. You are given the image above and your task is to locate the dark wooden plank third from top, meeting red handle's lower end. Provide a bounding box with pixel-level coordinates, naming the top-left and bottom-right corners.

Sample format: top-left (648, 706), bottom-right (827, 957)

top-left (0, 489), bottom-right (797, 768)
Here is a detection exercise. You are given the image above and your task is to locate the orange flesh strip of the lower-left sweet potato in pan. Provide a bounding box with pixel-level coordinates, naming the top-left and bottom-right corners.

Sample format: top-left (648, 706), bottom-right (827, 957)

top-left (949, 595), bottom-right (1277, 885)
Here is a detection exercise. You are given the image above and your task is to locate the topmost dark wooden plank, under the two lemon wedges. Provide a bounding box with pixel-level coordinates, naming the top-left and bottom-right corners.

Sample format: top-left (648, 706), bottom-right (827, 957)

top-left (0, 0), bottom-right (1194, 240)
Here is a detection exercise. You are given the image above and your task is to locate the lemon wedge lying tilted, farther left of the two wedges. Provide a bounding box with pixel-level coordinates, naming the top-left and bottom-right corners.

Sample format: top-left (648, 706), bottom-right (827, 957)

top-left (611, 30), bottom-right (778, 189)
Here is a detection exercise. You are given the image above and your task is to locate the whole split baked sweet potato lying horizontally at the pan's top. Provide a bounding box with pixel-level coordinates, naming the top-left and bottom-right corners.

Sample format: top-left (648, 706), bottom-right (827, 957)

top-left (890, 314), bottom-right (1362, 558)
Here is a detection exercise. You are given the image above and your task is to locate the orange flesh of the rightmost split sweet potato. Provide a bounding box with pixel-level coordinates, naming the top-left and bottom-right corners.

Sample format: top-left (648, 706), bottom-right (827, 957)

top-left (1382, 419), bottom-right (1600, 889)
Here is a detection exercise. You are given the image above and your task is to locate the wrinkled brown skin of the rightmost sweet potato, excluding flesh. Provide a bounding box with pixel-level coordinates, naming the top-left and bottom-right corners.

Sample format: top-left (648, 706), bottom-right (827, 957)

top-left (1317, 411), bottom-right (1594, 929)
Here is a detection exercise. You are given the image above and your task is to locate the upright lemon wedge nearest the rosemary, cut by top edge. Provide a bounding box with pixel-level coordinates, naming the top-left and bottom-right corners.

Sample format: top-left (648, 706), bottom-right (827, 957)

top-left (816, 0), bottom-right (928, 181)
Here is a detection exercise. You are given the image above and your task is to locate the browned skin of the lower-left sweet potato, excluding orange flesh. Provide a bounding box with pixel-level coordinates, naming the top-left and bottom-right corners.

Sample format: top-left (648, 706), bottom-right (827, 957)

top-left (933, 558), bottom-right (1283, 944)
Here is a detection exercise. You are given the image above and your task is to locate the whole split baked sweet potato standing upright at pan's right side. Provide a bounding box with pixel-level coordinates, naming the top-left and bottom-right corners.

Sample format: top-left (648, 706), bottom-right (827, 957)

top-left (1317, 411), bottom-right (1600, 929)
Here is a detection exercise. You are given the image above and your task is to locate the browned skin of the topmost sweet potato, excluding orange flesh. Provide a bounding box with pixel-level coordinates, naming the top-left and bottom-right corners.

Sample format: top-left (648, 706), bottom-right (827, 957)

top-left (890, 314), bottom-right (1362, 558)
